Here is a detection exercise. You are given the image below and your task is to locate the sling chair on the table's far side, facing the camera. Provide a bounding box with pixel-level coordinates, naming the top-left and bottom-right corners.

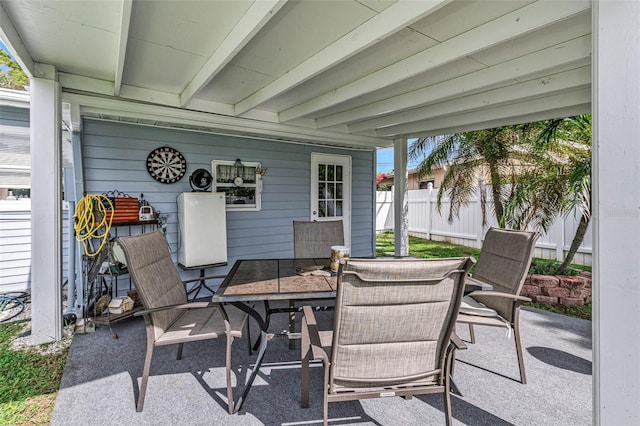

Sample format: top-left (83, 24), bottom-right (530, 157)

top-left (265, 220), bottom-right (344, 349)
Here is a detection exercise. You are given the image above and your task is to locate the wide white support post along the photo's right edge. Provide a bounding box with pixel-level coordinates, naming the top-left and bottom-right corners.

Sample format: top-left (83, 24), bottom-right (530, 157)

top-left (592, 1), bottom-right (640, 425)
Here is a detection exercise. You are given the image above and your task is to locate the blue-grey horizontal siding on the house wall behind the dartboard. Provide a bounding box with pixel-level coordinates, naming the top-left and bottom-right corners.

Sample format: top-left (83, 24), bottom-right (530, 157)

top-left (82, 119), bottom-right (375, 292)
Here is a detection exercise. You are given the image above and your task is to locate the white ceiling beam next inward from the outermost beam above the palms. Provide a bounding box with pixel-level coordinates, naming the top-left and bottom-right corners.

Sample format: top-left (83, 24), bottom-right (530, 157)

top-left (349, 66), bottom-right (591, 133)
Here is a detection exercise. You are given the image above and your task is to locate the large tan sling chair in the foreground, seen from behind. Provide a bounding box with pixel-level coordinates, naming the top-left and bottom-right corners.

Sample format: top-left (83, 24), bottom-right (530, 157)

top-left (301, 257), bottom-right (473, 425)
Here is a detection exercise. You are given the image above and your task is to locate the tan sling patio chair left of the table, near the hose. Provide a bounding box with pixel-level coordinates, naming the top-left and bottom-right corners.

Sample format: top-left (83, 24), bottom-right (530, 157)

top-left (117, 231), bottom-right (247, 414)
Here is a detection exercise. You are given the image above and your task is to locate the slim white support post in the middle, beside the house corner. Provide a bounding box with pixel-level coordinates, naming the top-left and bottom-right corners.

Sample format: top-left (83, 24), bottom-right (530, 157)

top-left (393, 139), bottom-right (409, 256)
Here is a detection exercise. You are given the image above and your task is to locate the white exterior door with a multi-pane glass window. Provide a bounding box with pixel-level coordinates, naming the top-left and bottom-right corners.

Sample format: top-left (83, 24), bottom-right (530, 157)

top-left (311, 152), bottom-right (351, 247)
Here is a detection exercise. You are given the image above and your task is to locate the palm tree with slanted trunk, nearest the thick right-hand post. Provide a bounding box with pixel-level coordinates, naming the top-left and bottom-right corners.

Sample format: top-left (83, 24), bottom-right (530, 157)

top-left (506, 114), bottom-right (591, 274)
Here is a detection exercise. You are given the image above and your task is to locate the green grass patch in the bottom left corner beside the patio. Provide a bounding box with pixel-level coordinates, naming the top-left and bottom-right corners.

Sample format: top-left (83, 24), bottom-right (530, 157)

top-left (0, 322), bottom-right (68, 425)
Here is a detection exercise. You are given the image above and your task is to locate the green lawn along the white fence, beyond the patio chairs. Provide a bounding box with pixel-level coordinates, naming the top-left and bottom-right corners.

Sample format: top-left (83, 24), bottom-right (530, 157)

top-left (376, 232), bottom-right (591, 320)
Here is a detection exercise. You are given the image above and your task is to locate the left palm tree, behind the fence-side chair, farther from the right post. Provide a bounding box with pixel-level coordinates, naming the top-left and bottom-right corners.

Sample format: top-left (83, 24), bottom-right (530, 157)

top-left (409, 126), bottom-right (527, 226)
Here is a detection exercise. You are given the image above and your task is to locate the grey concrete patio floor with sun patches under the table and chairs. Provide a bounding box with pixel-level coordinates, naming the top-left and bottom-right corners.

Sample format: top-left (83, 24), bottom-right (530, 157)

top-left (51, 309), bottom-right (592, 426)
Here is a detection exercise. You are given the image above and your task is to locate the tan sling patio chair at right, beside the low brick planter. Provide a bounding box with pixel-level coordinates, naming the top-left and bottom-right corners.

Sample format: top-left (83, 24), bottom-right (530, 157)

top-left (458, 228), bottom-right (540, 384)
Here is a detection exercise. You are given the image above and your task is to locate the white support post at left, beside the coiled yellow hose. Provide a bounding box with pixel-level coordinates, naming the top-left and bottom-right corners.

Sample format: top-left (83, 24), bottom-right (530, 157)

top-left (30, 64), bottom-right (62, 345)
